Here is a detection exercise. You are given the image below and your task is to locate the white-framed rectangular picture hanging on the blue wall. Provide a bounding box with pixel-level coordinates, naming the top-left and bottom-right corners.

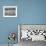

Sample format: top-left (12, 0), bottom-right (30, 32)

top-left (3, 6), bottom-right (17, 17)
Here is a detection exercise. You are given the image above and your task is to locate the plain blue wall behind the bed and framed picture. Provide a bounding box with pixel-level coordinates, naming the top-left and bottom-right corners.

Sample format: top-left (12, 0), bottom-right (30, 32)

top-left (0, 0), bottom-right (46, 44)
